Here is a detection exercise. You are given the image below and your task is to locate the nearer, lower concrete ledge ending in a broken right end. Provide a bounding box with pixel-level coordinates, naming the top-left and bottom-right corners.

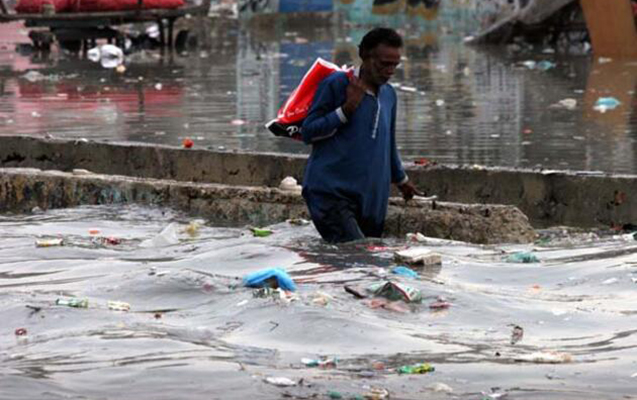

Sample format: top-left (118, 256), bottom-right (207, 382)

top-left (0, 168), bottom-right (535, 244)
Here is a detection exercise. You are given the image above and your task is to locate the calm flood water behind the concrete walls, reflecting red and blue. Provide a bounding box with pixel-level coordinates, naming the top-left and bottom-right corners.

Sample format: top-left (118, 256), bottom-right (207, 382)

top-left (0, 9), bottom-right (637, 174)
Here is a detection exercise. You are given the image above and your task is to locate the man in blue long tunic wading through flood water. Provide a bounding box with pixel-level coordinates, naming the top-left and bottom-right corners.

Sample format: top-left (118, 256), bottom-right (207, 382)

top-left (301, 28), bottom-right (420, 243)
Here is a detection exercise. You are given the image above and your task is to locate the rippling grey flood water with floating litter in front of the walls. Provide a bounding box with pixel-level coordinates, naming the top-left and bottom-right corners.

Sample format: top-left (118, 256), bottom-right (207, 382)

top-left (0, 206), bottom-right (637, 400)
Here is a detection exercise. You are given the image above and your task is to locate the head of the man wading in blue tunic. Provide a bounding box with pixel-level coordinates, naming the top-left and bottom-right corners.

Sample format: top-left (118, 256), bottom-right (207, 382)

top-left (358, 28), bottom-right (403, 86)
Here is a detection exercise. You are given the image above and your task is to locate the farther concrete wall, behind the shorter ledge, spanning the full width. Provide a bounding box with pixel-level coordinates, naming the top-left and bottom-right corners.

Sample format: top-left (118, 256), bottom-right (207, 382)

top-left (0, 137), bottom-right (637, 228)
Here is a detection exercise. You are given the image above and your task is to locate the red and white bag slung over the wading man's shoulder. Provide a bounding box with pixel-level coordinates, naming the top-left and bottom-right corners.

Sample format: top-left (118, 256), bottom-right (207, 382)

top-left (265, 57), bottom-right (353, 140)
